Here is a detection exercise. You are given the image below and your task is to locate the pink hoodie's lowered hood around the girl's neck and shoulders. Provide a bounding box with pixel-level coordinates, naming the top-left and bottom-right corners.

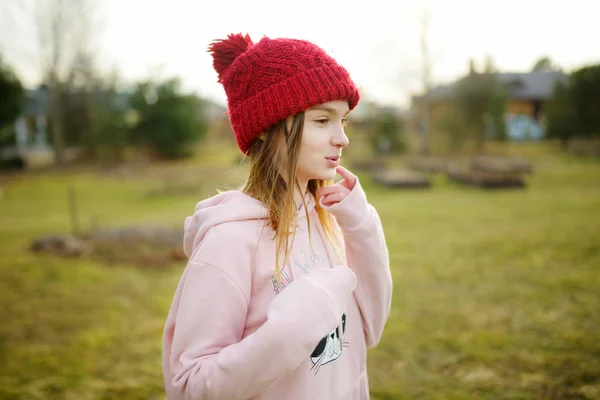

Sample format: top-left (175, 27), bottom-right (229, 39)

top-left (183, 190), bottom-right (315, 258)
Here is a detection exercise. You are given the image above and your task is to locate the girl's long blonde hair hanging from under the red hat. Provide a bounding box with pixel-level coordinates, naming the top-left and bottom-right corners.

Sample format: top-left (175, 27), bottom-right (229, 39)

top-left (243, 112), bottom-right (339, 280)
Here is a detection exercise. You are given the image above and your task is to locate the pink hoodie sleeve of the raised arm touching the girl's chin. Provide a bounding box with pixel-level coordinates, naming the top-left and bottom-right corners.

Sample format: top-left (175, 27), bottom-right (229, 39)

top-left (323, 178), bottom-right (392, 347)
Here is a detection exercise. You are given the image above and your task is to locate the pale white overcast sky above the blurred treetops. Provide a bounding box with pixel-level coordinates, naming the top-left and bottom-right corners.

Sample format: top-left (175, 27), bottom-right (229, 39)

top-left (0, 0), bottom-right (600, 107)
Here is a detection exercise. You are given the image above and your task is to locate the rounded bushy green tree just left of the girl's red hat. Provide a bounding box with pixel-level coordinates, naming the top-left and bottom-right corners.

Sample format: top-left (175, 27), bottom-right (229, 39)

top-left (131, 78), bottom-right (207, 158)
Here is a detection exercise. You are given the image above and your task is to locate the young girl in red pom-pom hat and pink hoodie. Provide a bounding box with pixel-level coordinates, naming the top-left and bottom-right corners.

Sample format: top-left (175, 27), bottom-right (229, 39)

top-left (163, 34), bottom-right (392, 400)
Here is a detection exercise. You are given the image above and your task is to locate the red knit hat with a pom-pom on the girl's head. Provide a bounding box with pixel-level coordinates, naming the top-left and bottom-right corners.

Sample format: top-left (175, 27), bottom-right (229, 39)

top-left (208, 33), bottom-right (360, 154)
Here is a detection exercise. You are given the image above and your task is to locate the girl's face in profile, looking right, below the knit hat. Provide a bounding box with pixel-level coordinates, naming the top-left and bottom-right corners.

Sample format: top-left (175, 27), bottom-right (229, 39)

top-left (296, 100), bottom-right (349, 184)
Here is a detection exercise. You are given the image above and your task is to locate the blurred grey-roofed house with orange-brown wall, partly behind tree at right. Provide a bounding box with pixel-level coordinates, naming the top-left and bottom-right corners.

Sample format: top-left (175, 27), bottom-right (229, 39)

top-left (410, 70), bottom-right (566, 140)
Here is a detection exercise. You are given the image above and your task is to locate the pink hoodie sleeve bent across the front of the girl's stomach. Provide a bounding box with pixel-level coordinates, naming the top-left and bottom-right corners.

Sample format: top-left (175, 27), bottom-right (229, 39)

top-left (163, 225), bottom-right (356, 400)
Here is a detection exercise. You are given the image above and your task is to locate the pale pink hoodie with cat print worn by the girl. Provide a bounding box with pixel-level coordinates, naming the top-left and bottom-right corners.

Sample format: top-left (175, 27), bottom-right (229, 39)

top-left (163, 176), bottom-right (392, 400)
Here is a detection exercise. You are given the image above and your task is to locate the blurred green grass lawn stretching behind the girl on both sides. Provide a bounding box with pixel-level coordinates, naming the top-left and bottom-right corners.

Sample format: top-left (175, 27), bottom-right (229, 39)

top-left (0, 145), bottom-right (600, 399)
